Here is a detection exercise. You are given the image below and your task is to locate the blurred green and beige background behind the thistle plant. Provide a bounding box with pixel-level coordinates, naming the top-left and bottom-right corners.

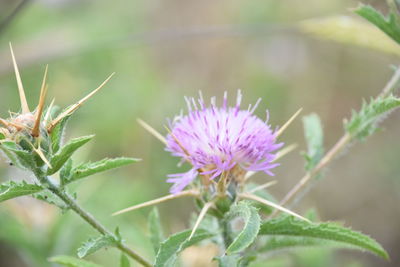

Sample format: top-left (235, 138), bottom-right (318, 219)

top-left (0, 0), bottom-right (400, 267)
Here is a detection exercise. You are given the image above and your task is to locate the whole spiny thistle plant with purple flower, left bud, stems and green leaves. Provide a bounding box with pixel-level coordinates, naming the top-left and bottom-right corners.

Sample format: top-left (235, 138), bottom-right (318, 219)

top-left (0, 1), bottom-right (400, 267)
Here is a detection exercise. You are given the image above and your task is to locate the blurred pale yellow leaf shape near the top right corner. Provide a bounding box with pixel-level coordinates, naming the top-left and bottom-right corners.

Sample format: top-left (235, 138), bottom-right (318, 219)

top-left (299, 16), bottom-right (400, 56)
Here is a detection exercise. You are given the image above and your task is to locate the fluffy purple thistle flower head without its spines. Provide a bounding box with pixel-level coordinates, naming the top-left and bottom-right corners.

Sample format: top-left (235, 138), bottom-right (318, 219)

top-left (166, 90), bottom-right (283, 194)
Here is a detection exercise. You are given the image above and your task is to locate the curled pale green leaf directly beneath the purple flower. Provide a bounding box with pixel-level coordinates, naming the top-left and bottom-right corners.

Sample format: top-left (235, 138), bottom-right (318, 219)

top-left (225, 201), bottom-right (261, 255)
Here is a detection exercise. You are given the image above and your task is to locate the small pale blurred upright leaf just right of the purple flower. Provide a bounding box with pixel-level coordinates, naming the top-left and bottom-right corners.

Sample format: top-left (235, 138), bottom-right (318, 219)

top-left (303, 113), bottom-right (324, 171)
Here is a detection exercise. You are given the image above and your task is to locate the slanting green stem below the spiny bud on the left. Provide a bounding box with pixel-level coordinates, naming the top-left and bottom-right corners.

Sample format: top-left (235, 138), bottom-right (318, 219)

top-left (36, 175), bottom-right (152, 267)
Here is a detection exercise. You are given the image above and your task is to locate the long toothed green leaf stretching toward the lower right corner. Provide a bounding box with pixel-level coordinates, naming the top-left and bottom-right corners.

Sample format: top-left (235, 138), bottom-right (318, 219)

top-left (259, 215), bottom-right (389, 259)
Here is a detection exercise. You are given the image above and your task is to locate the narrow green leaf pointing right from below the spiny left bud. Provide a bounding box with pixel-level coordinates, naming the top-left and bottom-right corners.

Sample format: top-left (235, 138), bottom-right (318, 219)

top-left (68, 157), bottom-right (139, 183)
